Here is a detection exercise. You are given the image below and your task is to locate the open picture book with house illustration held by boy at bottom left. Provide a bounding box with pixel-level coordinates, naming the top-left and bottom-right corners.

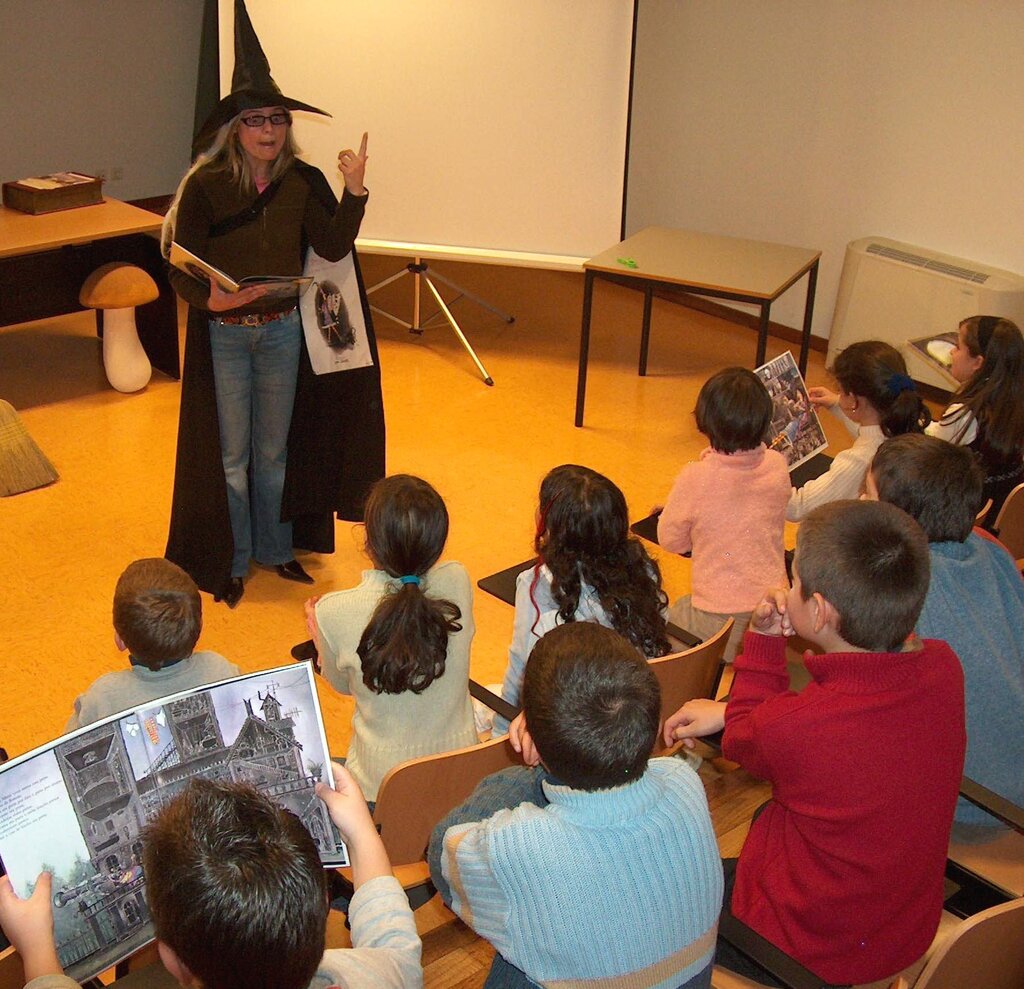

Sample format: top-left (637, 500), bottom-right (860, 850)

top-left (0, 663), bottom-right (348, 982)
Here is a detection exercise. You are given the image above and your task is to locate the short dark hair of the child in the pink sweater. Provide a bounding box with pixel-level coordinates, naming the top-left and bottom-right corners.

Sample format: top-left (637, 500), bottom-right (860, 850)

top-left (693, 368), bottom-right (772, 454)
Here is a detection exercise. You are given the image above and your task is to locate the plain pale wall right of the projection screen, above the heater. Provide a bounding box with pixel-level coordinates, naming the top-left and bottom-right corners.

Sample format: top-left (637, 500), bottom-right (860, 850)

top-left (627, 0), bottom-right (1024, 336)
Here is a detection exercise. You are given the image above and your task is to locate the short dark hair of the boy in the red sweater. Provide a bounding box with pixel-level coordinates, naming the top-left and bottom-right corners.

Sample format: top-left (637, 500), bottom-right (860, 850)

top-left (794, 502), bottom-right (931, 652)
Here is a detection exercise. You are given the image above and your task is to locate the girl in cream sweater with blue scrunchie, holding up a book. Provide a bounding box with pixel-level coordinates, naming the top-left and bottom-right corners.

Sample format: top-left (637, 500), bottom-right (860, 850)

top-left (785, 340), bottom-right (932, 522)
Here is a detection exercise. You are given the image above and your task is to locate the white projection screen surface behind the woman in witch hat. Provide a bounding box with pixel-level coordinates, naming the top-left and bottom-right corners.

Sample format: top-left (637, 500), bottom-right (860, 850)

top-left (232, 0), bottom-right (633, 257)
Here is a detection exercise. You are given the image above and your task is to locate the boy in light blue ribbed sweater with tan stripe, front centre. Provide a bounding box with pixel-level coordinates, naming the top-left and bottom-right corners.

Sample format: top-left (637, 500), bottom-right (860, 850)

top-left (429, 621), bottom-right (722, 989)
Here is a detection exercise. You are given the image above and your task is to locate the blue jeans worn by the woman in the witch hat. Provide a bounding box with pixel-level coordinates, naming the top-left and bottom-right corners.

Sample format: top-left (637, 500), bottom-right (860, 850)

top-left (210, 309), bottom-right (302, 576)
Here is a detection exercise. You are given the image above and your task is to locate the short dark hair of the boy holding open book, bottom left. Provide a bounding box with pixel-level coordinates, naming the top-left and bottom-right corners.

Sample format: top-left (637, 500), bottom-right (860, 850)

top-left (142, 779), bottom-right (328, 989)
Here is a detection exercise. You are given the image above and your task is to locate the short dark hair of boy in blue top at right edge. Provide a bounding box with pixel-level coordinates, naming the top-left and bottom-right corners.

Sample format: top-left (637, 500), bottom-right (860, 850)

top-left (871, 433), bottom-right (985, 543)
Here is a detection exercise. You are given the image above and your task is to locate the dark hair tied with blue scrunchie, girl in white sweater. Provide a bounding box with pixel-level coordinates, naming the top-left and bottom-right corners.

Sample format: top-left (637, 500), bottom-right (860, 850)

top-left (833, 340), bottom-right (932, 436)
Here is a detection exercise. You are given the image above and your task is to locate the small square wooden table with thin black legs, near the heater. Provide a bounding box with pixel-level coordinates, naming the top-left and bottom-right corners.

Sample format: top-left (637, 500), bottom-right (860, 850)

top-left (575, 226), bottom-right (821, 426)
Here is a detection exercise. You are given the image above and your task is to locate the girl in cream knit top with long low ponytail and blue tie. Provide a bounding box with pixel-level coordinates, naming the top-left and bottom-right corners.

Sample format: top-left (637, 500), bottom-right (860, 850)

top-left (306, 474), bottom-right (477, 802)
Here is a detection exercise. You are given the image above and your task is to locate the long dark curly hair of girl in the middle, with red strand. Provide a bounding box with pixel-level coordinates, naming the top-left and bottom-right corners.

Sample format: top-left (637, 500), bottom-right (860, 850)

top-left (530, 464), bottom-right (671, 657)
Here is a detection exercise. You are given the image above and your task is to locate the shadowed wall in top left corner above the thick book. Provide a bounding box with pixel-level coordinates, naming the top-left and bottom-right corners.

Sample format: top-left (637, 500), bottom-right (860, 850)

top-left (0, 0), bottom-right (203, 200)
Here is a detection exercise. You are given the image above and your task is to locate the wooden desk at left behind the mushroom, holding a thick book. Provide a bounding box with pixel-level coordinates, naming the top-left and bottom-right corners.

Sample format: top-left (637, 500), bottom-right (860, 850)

top-left (0, 199), bottom-right (181, 378)
